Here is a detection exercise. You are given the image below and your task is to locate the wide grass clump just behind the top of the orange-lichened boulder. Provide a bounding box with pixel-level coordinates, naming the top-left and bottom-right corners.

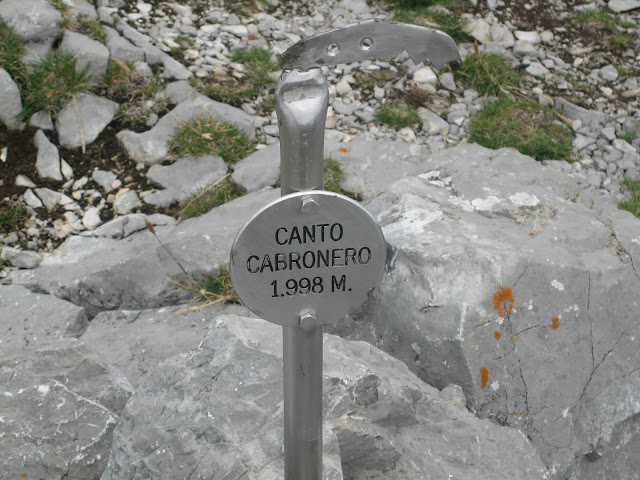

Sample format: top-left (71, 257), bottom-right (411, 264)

top-left (469, 97), bottom-right (573, 161)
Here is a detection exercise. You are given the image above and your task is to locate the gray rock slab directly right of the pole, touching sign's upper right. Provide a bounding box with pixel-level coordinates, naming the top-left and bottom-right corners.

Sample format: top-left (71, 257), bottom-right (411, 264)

top-left (325, 138), bottom-right (429, 200)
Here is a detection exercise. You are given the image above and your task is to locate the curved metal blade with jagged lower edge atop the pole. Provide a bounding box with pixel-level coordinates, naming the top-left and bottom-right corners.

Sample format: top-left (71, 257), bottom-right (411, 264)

top-left (276, 20), bottom-right (461, 71)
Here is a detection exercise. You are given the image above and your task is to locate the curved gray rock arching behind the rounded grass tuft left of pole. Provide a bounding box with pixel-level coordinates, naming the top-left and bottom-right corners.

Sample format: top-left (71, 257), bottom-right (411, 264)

top-left (116, 95), bottom-right (255, 165)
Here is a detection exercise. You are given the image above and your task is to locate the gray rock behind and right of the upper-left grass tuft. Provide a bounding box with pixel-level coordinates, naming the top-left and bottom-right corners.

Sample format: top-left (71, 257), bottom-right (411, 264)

top-left (58, 30), bottom-right (109, 83)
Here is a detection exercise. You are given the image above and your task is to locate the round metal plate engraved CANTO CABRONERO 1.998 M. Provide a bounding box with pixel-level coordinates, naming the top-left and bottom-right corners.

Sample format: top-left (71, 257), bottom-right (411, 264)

top-left (231, 190), bottom-right (386, 327)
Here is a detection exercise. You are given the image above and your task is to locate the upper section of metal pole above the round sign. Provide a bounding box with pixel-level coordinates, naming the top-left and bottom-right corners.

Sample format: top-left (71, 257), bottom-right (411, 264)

top-left (275, 68), bottom-right (329, 195)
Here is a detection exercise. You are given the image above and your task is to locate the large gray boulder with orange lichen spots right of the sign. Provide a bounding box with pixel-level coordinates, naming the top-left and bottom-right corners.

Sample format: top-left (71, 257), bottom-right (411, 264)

top-left (338, 144), bottom-right (640, 478)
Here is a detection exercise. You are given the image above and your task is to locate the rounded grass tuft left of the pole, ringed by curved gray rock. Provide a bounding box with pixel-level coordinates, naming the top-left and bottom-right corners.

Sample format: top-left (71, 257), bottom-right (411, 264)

top-left (171, 118), bottom-right (255, 164)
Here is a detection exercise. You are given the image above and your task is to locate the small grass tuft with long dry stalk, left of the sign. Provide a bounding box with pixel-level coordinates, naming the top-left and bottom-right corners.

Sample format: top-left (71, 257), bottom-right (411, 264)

top-left (144, 218), bottom-right (240, 315)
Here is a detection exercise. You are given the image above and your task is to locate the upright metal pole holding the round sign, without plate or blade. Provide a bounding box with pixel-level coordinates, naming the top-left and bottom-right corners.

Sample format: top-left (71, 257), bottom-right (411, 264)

top-left (275, 68), bottom-right (329, 480)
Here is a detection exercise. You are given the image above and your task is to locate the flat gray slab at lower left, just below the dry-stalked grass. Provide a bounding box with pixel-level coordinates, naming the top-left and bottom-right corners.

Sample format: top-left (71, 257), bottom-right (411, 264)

top-left (81, 303), bottom-right (255, 389)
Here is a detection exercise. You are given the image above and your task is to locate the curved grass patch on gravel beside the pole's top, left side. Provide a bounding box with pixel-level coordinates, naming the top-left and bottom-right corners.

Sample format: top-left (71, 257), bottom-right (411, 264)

top-left (192, 48), bottom-right (278, 107)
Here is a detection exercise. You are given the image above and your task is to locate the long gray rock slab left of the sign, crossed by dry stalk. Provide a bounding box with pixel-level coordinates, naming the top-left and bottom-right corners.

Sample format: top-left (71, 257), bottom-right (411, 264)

top-left (10, 190), bottom-right (280, 318)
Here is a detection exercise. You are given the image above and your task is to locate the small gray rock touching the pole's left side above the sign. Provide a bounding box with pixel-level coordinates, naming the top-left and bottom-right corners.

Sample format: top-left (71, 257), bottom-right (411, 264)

top-left (231, 143), bottom-right (280, 192)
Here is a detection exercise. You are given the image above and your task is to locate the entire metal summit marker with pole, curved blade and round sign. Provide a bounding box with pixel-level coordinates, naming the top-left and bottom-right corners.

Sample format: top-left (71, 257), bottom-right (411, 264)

top-left (230, 20), bottom-right (460, 480)
